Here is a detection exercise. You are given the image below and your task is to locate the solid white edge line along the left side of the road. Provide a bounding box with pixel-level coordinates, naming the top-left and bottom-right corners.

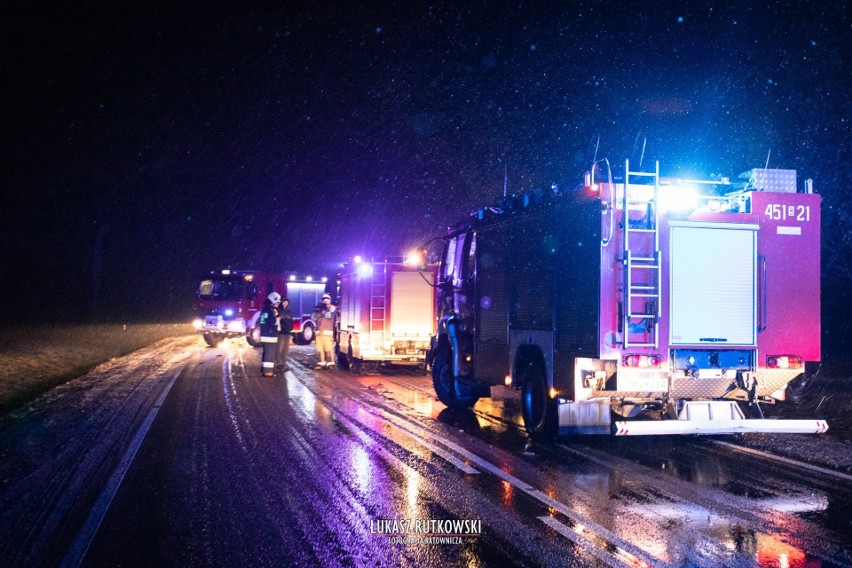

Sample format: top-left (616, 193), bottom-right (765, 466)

top-left (60, 365), bottom-right (185, 568)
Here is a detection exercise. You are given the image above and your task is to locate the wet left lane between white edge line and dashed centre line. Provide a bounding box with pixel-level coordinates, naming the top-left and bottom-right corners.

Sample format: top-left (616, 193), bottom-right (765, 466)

top-left (82, 348), bottom-right (598, 566)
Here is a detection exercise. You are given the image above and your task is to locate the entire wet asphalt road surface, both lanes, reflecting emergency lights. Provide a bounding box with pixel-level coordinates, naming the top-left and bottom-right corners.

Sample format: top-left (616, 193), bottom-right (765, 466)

top-left (0, 342), bottom-right (852, 566)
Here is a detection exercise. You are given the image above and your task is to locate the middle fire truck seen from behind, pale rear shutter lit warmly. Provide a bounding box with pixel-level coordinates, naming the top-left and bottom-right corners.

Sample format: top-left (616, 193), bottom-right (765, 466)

top-left (337, 252), bottom-right (437, 368)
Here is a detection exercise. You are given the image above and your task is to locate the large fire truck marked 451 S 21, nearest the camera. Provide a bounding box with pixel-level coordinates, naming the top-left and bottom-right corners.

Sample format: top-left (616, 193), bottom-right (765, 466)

top-left (430, 160), bottom-right (828, 438)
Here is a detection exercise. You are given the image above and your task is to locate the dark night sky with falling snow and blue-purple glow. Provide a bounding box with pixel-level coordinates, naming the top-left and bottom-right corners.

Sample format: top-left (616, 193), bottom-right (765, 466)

top-left (0, 1), bottom-right (852, 358)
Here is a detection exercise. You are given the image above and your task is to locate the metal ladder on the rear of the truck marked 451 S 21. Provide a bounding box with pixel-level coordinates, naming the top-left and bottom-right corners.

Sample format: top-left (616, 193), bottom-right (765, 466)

top-left (621, 160), bottom-right (661, 348)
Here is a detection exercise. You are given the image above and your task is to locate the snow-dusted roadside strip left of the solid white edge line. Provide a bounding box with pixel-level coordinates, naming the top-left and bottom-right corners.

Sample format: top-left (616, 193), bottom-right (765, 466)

top-left (0, 330), bottom-right (205, 566)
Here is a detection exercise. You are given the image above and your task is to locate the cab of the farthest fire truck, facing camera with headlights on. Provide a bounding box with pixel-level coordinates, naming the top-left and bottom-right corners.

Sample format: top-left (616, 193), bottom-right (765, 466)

top-left (192, 269), bottom-right (287, 347)
